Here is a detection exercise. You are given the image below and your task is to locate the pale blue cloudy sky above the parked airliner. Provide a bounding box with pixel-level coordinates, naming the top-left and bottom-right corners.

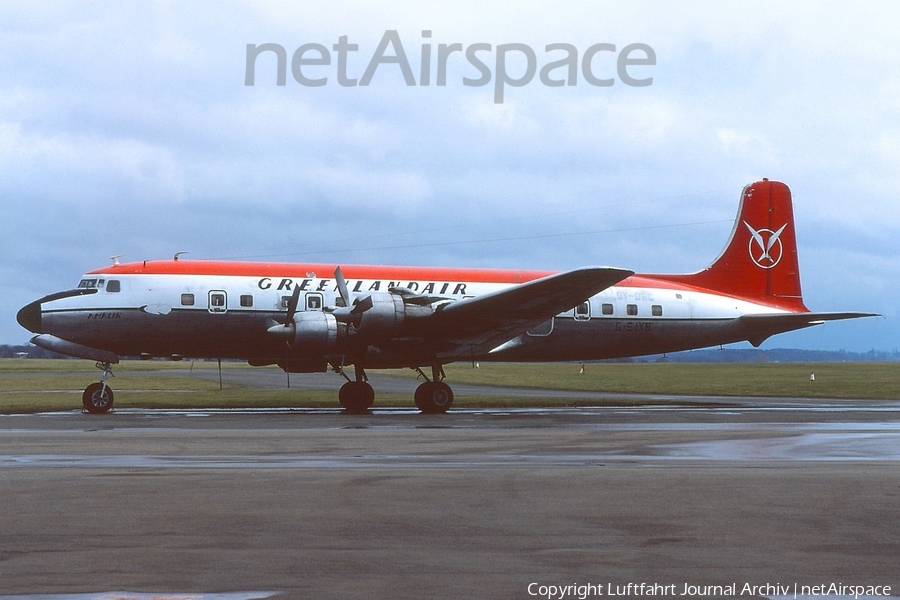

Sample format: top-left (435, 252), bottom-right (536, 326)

top-left (0, 0), bottom-right (900, 351)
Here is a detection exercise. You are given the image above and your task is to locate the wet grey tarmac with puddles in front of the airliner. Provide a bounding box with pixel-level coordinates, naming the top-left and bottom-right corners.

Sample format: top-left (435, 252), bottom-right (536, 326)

top-left (0, 397), bottom-right (900, 600)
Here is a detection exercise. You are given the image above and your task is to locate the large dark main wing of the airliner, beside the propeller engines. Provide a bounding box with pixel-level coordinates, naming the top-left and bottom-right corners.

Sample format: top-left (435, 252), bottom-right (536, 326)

top-left (428, 267), bottom-right (634, 358)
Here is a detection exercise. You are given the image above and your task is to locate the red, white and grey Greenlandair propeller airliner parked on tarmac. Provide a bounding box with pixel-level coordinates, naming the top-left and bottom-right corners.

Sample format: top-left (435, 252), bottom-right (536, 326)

top-left (17, 179), bottom-right (877, 413)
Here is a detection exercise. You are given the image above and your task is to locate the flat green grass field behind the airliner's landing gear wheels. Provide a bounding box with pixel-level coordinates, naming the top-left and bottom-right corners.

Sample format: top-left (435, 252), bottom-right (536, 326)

top-left (0, 359), bottom-right (900, 414)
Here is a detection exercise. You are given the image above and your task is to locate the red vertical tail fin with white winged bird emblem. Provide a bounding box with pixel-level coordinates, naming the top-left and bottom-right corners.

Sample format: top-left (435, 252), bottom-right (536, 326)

top-left (660, 179), bottom-right (808, 312)
